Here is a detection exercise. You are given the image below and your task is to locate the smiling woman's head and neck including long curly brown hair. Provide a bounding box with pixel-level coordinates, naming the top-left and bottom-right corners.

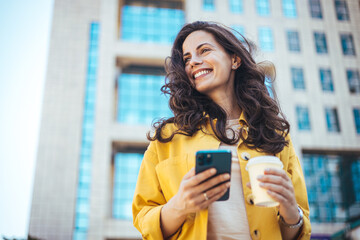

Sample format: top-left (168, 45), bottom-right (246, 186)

top-left (149, 22), bottom-right (290, 153)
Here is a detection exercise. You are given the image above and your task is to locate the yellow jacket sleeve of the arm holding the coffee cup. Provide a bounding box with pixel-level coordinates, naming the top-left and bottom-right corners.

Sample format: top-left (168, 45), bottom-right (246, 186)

top-left (285, 136), bottom-right (311, 240)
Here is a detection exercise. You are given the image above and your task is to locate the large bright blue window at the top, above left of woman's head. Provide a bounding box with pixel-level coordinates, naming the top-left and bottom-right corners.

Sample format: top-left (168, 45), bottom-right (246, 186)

top-left (121, 5), bottom-right (185, 43)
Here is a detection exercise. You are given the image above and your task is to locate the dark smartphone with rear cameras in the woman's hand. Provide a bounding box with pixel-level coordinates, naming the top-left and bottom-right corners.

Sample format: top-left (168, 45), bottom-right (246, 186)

top-left (195, 150), bottom-right (231, 201)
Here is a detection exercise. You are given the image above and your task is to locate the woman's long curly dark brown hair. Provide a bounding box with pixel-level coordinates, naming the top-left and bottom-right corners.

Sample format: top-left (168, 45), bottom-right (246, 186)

top-left (147, 21), bottom-right (290, 154)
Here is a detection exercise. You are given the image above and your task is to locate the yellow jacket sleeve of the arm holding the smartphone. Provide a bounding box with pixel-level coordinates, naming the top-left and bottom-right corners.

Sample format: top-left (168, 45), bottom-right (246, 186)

top-left (132, 142), bottom-right (166, 240)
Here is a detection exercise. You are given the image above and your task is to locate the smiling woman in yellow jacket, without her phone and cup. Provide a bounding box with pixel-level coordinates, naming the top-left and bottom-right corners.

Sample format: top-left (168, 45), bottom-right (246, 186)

top-left (133, 22), bottom-right (311, 239)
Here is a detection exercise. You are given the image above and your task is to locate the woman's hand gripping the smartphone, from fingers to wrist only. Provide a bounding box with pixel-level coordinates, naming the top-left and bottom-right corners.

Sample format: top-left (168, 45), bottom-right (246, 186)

top-left (169, 168), bottom-right (230, 215)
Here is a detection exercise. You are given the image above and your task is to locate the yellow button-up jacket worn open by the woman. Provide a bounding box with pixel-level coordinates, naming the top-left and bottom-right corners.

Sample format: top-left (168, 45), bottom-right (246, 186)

top-left (132, 115), bottom-right (311, 240)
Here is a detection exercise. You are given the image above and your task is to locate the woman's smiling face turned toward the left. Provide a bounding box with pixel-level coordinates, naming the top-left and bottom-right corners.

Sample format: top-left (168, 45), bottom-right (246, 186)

top-left (182, 31), bottom-right (236, 100)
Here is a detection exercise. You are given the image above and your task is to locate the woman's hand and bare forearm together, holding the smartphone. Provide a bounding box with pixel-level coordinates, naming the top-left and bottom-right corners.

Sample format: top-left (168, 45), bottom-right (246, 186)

top-left (160, 168), bottom-right (230, 239)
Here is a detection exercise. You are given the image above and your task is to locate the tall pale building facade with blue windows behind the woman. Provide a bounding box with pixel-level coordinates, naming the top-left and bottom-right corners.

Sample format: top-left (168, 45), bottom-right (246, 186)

top-left (29, 0), bottom-right (360, 240)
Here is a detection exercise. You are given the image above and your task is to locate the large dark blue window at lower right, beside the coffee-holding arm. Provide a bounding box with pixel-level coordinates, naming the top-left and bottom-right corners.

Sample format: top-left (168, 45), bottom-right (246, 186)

top-left (302, 152), bottom-right (360, 223)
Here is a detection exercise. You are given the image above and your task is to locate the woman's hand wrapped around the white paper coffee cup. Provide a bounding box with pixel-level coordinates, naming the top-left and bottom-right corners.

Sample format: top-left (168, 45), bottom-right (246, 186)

top-left (258, 168), bottom-right (300, 224)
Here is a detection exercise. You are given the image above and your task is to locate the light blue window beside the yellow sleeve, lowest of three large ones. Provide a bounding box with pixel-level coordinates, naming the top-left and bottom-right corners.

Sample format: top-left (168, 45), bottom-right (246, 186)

top-left (112, 153), bottom-right (144, 220)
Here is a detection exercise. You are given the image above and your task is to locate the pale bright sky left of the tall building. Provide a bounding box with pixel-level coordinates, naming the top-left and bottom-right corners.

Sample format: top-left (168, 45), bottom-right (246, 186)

top-left (0, 0), bottom-right (53, 236)
